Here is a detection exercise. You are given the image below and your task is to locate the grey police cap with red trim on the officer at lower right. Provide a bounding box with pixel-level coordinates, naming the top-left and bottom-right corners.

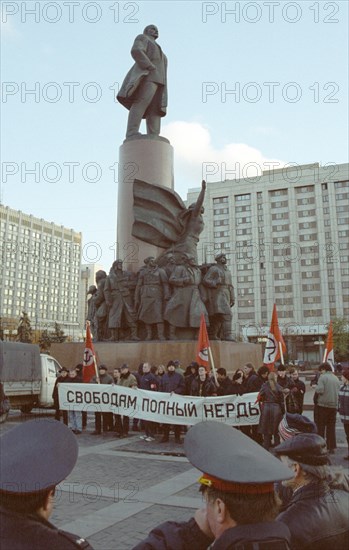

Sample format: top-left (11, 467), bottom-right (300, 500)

top-left (184, 421), bottom-right (293, 495)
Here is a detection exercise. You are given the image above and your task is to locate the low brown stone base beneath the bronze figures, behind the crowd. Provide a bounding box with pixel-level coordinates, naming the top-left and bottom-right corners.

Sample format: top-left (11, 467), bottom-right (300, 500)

top-left (50, 340), bottom-right (263, 373)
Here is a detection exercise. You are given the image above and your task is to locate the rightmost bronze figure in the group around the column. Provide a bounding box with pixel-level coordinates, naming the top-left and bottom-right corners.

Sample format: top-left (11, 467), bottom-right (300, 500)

top-left (203, 254), bottom-right (235, 340)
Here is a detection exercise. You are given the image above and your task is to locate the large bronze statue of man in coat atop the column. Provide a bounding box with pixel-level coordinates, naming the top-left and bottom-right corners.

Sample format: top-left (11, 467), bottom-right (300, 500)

top-left (117, 25), bottom-right (167, 139)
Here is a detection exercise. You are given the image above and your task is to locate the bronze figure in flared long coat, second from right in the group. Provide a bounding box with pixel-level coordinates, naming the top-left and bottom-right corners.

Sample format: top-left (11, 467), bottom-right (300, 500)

top-left (164, 254), bottom-right (208, 340)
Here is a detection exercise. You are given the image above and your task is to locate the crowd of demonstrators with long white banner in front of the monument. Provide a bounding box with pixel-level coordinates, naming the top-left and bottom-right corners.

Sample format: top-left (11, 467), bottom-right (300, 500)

top-left (53, 360), bottom-right (349, 457)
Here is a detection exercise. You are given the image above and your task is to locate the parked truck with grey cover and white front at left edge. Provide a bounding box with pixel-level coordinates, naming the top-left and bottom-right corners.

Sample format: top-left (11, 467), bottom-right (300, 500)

top-left (0, 341), bottom-right (61, 422)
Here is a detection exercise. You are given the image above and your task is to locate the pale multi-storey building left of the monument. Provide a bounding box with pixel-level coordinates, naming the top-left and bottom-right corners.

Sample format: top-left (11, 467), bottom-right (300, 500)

top-left (0, 205), bottom-right (82, 337)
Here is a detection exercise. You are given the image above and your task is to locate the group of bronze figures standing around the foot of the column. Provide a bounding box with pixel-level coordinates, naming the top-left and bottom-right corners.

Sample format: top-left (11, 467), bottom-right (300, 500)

top-left (87, 249), bottom-right (234, 341)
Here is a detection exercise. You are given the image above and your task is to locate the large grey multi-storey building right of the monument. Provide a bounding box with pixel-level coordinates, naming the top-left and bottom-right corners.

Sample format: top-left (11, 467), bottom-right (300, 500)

top-left (187, 164), bottom-right (349, 359)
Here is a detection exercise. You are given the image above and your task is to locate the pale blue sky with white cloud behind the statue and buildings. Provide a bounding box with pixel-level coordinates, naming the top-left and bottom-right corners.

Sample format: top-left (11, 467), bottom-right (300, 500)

top-left (1, 1), bottom-right (348, 269)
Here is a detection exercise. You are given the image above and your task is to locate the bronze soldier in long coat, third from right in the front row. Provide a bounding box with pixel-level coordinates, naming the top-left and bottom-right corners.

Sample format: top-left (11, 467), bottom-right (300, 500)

top-left (135, 256), bottom-right (170, 340)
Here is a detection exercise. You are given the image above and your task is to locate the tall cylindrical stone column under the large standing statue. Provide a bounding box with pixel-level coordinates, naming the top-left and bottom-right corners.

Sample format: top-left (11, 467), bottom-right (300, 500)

top-left (117, 136), bottom-right (174, 272)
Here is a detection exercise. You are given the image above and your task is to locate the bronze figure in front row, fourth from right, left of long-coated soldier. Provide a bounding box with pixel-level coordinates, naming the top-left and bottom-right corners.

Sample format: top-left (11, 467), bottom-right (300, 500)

top-left (104, 260), bottom-right (139, 341)
